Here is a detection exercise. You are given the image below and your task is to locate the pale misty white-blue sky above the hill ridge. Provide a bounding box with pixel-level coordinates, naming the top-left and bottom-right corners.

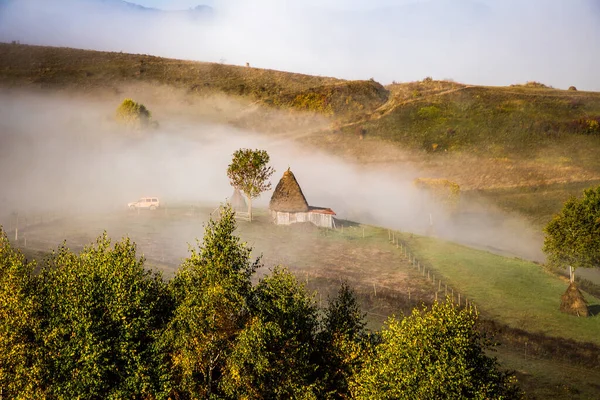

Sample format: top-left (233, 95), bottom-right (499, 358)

top-left (0, 0), bottom-right (600, 90)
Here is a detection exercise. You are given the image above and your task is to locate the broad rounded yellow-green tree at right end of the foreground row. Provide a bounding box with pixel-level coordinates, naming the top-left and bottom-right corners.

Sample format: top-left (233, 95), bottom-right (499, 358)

top-left (351, 303), bottom-right (521, 400)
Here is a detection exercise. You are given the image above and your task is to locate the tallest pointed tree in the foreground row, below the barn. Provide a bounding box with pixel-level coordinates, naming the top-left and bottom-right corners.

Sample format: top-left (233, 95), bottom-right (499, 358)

top-left (164, 206), bottom-right (260, 398)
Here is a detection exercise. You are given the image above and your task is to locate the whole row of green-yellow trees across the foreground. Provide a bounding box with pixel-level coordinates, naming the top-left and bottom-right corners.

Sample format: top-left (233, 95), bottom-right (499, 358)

top-left (0, 211), bottom-right (518, 399)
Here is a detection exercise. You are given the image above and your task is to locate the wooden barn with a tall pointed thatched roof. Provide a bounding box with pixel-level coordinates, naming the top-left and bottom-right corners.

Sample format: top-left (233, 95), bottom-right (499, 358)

top-left (269, 168), bottom-right (335, 229)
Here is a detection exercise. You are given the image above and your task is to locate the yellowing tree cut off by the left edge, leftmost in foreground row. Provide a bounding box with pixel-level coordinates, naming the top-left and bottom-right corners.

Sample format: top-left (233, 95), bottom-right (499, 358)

top-left (0, 227), bottom-right (43, 399)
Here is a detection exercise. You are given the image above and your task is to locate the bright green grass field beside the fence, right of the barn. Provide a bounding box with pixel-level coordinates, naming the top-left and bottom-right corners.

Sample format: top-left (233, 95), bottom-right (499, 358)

top-left (402, 234), bottom-right (600, 345)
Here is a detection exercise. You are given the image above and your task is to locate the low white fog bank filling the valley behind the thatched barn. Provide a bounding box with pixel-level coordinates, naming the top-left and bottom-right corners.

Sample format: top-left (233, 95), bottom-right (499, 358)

top-left (0, 91), bottom-right (541, 259)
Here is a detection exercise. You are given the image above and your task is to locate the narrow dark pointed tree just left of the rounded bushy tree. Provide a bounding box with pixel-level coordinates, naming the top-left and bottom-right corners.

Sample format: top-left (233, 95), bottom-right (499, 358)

top-left (317, 282), bottom-right (367, 399)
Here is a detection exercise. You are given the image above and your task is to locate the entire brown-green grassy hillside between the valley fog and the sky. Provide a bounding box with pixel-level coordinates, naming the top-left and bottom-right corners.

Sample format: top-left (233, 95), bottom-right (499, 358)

top-left (0, 44), bottom-right (600, 227)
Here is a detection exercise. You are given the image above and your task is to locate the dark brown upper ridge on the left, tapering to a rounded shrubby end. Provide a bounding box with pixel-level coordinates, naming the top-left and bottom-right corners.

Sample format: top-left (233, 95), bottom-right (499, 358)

top-left (0, 44), bottom-right (388, 115)
